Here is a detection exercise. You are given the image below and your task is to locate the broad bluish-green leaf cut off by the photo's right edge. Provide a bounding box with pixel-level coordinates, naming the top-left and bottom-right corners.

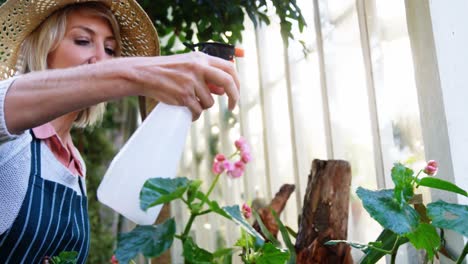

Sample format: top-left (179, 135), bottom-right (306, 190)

top-left (427, 200), bottom-right (468, 237)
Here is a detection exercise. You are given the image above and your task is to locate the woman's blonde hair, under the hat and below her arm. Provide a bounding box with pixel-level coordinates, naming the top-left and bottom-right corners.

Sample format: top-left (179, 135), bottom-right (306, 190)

top-left (17, 2), bottom-right (122, 128)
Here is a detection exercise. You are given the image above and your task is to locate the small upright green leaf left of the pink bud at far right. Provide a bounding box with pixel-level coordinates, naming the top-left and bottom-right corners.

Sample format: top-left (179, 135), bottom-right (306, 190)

top-left (392, 163), bottom-right (414, 205)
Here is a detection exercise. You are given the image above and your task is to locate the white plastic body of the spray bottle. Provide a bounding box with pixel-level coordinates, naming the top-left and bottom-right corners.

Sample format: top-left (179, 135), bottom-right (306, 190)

top-left (97, 103), bottom-right (192, 225)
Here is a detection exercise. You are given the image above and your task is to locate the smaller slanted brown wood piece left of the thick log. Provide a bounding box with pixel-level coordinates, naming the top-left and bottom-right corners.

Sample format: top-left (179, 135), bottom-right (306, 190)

top-left (253, 184), bottom-right (295, 237)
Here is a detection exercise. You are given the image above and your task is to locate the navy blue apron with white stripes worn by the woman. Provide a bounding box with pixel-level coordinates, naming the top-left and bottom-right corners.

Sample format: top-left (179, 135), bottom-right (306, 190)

top-left (0, 132), bottom-right (89, 264)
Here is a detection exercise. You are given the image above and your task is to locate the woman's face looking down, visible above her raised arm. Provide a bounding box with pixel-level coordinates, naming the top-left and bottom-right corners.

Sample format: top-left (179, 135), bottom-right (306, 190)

top-left (47, 10), bottom-right (117, 69)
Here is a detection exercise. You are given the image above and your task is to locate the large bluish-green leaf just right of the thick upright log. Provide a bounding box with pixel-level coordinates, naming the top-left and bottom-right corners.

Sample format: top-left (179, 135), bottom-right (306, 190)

top-left (356, 187), bottom-right (419, 235)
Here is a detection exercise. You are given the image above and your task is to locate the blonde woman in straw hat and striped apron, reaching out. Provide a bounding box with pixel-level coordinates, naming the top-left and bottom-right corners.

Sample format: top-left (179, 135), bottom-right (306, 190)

top-left (0, 0), bottom-right (239, 263)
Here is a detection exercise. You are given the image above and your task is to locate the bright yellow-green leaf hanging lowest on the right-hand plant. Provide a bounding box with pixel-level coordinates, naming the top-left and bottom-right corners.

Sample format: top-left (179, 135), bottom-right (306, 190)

top-left (405, 223), bottom-right (440, 260)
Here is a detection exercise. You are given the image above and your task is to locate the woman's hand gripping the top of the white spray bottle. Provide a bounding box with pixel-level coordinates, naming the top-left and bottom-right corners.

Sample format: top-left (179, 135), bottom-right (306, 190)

top-left (117, 52), bottom-right (239, 120)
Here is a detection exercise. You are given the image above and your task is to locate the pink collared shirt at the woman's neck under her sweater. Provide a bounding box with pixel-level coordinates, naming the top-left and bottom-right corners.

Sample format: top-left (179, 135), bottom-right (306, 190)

top-left (32, 123), bottom-right (83, 176)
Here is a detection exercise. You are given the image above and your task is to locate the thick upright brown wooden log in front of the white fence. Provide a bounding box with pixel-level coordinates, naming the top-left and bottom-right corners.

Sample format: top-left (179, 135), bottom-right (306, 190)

top-left (295, 160), bottom-right (353, 264)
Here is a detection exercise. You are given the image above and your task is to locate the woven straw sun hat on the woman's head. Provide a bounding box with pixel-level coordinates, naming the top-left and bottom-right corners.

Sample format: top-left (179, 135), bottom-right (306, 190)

top-left (0, 0), bottom-right (159, 80)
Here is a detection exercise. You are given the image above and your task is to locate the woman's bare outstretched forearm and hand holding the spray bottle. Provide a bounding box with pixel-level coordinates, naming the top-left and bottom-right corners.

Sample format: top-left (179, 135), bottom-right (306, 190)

top-left (5, 52), bottom-right (239, 134)
